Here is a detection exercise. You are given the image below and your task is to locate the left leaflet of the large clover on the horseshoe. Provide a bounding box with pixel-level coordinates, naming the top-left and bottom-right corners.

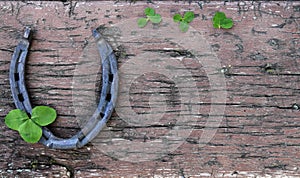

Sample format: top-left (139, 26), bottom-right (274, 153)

top-left (5, 109), bottom-right (29, 130)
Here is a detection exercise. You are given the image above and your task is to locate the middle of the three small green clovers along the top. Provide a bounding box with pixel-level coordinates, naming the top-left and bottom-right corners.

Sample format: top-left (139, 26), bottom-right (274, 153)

top-left (173, 11), bottom-right (195, 32)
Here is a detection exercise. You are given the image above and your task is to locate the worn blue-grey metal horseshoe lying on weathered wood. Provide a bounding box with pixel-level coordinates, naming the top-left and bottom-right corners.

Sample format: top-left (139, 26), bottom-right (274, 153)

top-left (9, 27), bottom-right (119, 149)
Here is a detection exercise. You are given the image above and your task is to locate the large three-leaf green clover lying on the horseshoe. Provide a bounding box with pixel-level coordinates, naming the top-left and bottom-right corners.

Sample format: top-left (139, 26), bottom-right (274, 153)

top-left (5, 106), bottom-right (56, 143)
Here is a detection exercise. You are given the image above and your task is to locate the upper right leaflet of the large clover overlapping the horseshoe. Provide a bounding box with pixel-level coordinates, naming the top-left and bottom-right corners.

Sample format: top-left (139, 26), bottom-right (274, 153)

top-left (31, 106), bottom-right (56, 126)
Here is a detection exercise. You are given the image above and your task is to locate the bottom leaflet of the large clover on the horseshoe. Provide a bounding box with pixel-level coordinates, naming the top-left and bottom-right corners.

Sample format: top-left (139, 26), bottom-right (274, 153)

top-left (19, 119), bottom-right (42, 143)
